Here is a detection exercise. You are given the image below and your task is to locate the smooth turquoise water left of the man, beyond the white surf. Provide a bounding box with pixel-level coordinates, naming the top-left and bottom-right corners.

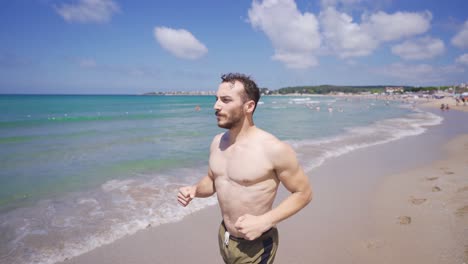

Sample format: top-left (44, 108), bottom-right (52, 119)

top-left (0, 96), bottom-right (213, 207)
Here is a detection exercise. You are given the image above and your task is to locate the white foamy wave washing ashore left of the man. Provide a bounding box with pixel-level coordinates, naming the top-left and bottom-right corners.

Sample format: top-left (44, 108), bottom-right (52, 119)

top-left (0, 168), bottom-right (217, 264)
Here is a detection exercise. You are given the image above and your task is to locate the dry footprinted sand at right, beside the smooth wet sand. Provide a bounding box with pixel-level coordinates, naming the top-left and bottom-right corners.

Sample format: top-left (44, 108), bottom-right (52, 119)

top-left (357, 135), bottom-right (468, 264)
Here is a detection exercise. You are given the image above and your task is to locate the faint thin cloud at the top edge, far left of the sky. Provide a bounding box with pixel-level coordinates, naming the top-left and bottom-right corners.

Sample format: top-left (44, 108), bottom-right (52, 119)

top-left (55, 0), bottom-right (120, 23)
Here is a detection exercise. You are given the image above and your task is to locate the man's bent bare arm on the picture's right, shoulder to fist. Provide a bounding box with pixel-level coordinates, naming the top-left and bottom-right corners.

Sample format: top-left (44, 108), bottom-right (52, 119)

top-left (235, 142), bottom-right (312, 240)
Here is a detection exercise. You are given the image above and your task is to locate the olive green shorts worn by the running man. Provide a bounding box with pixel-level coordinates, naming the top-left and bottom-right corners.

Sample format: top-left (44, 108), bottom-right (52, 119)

top-left (218, 222), bottom-right (279, 264)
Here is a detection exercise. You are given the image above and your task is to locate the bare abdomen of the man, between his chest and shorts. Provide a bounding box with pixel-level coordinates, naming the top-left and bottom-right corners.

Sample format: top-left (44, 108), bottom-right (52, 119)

top-left (215, 176), bottom-right (278, 237)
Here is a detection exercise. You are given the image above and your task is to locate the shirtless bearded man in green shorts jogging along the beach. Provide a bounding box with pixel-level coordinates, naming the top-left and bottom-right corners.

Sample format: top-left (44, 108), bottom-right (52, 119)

top-left (177, 73), bottom-right (312, 263)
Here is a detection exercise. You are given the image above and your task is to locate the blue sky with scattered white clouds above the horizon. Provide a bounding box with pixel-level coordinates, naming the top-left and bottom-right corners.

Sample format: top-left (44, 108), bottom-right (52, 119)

top-left (0, 0), bottom-right (468, 94)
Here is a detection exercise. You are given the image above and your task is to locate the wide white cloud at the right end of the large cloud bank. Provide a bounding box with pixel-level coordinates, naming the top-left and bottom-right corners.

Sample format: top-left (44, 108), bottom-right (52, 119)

top-left (362, 11), bottom-right (432, 41)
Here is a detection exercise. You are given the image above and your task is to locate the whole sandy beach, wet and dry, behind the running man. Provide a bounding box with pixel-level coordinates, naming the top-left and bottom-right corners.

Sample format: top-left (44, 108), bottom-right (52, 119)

top-left (63, 105), bottom-right (468, 264)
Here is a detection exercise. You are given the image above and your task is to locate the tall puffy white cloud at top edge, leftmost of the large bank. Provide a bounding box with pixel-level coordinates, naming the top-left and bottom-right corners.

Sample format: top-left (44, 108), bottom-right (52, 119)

top-left (248, 0), bottom-right (321, 69)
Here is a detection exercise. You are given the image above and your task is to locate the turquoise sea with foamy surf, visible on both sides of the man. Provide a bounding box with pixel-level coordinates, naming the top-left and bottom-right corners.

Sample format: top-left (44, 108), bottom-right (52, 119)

top-left (0, 95), bottom-right (442, 264)
